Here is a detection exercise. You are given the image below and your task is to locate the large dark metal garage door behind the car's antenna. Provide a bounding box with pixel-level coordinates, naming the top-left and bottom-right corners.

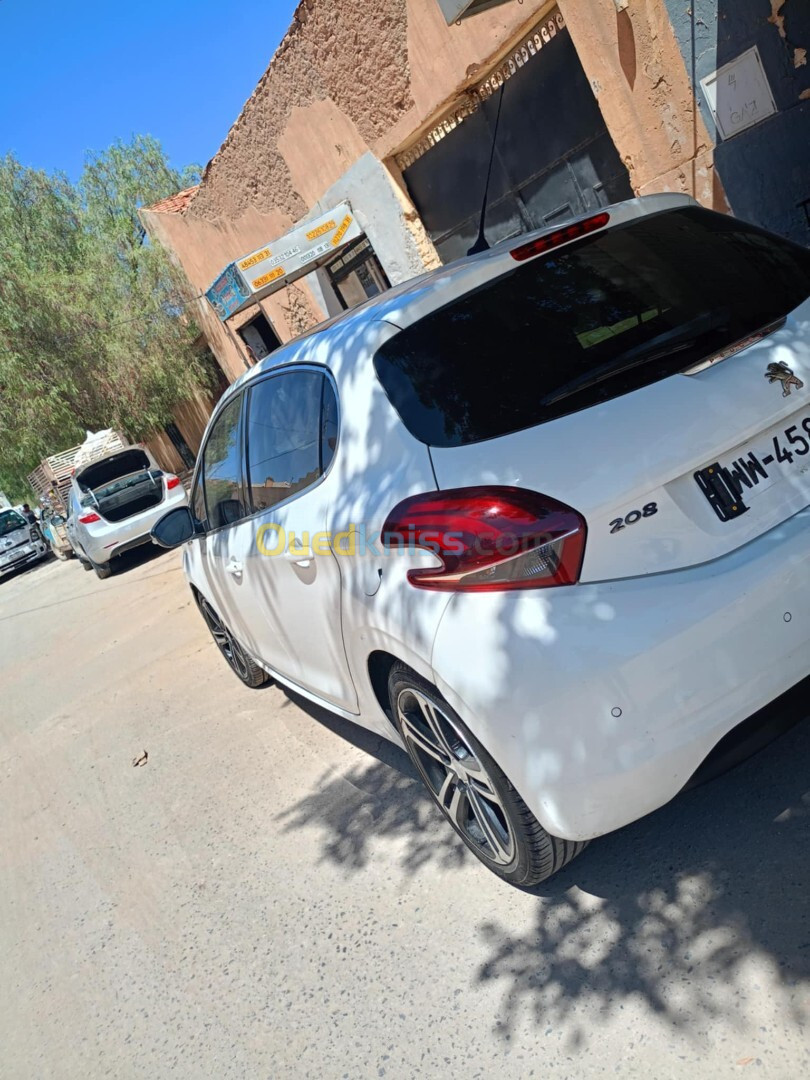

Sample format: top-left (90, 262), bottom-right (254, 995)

top-left (403, 23), bottom-right (633, 262)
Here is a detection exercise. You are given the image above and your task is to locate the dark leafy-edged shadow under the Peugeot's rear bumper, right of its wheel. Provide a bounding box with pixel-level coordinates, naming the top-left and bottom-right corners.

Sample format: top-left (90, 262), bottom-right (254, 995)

top-left (477, 720), bottom-right (810, 1035)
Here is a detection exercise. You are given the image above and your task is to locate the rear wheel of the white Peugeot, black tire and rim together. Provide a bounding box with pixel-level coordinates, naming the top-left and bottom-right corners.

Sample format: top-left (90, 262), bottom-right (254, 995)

top-left (388, 664), bottom-right (588, 889)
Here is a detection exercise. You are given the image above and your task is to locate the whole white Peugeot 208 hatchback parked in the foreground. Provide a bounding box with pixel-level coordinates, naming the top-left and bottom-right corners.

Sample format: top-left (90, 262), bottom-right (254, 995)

top-left (153, 195), bottom-right (810, 886)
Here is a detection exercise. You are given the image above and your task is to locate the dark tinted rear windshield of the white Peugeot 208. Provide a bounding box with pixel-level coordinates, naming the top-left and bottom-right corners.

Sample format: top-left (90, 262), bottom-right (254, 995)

top-left (375, 207), bottom-right (810, 447)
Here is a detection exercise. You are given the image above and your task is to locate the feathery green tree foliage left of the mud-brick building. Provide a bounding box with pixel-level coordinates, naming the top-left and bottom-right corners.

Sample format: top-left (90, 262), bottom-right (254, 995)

top-left (0, 136), bottom-right (212, 495)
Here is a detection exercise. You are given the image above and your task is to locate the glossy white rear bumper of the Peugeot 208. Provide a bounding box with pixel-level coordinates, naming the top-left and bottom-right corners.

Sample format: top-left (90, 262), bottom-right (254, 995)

top-left (432, 510), bottom-right (810, 840)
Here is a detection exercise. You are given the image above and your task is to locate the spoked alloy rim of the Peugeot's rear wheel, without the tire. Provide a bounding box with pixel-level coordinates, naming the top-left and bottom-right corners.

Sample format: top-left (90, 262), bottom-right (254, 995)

top-left (396, 688), bottom-right (516, 866)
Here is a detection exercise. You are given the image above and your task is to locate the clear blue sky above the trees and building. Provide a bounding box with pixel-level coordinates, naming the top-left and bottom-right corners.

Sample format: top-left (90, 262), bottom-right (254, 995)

top-left (0, 0), bottom-right (297, 179)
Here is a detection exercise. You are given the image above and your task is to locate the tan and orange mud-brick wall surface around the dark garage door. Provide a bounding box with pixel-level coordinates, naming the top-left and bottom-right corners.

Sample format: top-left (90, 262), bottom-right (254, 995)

top-left (143, 0), bottom-right (743, 378)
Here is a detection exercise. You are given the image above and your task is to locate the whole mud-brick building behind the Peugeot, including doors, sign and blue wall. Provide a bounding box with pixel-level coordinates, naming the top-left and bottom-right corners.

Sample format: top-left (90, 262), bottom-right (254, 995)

top-left (141, 0), bottom-right (810, 379)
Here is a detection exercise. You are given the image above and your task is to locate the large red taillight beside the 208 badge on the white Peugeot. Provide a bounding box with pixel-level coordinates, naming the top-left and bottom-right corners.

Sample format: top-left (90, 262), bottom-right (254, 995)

top-left (382, 487), bottom-right (586, 593)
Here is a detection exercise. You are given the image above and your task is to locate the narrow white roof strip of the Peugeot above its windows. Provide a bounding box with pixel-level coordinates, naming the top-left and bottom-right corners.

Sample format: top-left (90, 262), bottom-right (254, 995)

top-left (224, 192), bottom-right (698, 400)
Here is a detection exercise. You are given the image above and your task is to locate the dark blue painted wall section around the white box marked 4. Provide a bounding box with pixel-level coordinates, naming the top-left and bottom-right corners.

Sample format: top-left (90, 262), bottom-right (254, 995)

top-left (665, 0), bottom-right (810, 244)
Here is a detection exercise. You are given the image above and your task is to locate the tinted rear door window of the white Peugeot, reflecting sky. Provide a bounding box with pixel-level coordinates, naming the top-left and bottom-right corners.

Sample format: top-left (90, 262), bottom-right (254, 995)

top-left (247, 370), bottom-right (337, 512)
